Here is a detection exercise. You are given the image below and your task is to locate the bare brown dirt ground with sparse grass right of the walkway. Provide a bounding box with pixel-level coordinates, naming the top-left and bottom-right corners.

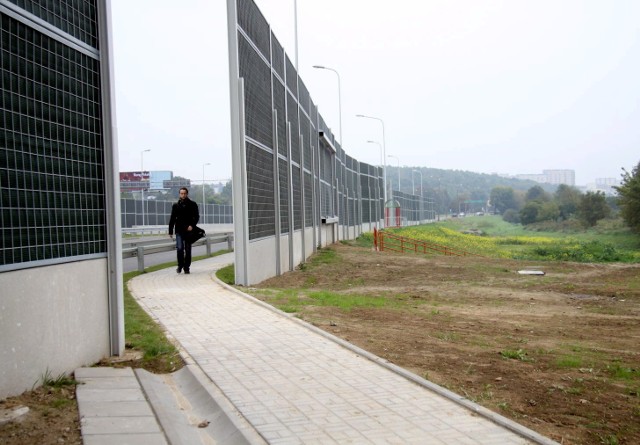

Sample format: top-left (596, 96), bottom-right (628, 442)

top-left (248, 244), bottom-right (640, 445)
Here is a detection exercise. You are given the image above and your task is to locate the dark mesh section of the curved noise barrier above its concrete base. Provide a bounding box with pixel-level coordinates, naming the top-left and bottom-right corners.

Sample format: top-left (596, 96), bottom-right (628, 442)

top-left (236, 0), bottom-right (392, 246)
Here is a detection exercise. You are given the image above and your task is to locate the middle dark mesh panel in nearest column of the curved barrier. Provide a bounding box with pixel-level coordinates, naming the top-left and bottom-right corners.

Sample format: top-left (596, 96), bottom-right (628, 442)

top-left (238, 34), bottom-right (273, 147)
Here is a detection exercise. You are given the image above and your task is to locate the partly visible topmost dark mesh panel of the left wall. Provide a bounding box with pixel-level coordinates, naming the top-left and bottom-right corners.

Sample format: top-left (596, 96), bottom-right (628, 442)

top-left (8, 0), bottom-right (99, 49)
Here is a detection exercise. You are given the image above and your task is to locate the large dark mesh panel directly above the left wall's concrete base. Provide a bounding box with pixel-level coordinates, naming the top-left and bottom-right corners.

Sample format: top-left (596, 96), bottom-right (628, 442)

top-left (0, 14), bottom-right (106, 265)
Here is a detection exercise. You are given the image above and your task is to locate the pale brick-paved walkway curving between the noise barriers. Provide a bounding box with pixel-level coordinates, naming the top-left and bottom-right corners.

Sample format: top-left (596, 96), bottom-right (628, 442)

top-left (130, 254), bottom-right (556, 445)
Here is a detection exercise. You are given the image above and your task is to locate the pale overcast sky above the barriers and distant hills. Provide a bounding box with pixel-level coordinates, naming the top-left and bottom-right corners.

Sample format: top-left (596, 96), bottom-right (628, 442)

top-left (111, 0), bottom-right (640, 185)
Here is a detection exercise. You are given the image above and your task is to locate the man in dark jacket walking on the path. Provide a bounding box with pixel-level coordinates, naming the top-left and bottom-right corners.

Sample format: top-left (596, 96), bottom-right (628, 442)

top-left (169, 187), bottom-right (200, 274)
